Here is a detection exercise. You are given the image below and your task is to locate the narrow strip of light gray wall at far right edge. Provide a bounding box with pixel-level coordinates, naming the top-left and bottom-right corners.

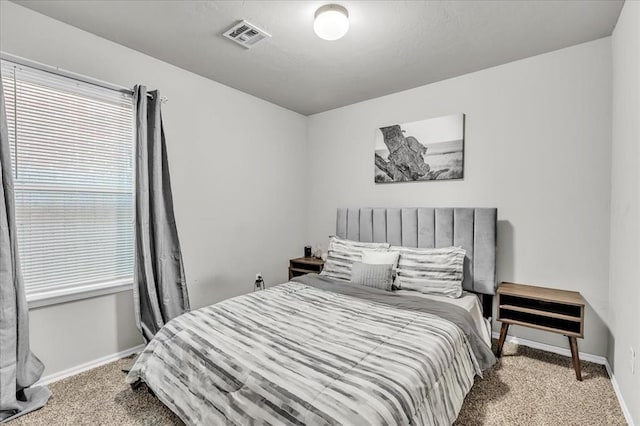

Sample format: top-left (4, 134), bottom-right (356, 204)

top-left (609, 1), bottom-right (640, 424)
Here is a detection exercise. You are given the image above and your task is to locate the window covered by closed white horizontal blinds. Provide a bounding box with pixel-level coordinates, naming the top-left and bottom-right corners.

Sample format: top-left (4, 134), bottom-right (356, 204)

top-left (1, 60), bottom-right (134, 306)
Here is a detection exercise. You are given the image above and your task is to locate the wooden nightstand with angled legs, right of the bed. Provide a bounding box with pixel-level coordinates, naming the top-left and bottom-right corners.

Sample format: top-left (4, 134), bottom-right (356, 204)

top-left (497, 283), bottom-right (584, 380)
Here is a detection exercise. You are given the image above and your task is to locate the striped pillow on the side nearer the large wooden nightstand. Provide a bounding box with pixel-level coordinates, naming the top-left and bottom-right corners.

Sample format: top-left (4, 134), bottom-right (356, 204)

top-left (391, 247), bottom-right (466, 297)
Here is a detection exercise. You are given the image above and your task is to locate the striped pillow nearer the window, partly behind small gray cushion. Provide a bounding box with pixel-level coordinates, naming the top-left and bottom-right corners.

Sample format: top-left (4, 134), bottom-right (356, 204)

top-left (320, 237), bottom-right (389, 281)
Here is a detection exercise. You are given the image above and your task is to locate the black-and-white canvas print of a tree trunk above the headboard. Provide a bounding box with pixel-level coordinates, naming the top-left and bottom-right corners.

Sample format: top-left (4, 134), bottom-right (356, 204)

top-left (374, 114), bottom-right (464, 183)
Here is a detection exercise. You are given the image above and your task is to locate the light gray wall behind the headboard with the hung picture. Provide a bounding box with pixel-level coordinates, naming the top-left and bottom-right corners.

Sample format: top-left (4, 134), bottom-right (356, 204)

top-left (307, 38), bottom-right (611, 355)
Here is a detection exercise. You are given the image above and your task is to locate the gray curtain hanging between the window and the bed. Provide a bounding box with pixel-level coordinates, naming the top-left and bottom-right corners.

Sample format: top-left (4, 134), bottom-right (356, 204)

top-left (133, 86), bottom-right (189, 342)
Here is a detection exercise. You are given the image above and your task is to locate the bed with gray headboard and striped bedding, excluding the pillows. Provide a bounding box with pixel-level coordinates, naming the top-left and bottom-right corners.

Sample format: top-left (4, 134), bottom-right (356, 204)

top-left (127, 208), bottom-right (496, 425)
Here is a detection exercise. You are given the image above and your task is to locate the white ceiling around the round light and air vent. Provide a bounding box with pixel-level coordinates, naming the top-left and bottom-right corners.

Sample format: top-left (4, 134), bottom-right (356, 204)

top-left (14, 0), bottom-right (623, 115)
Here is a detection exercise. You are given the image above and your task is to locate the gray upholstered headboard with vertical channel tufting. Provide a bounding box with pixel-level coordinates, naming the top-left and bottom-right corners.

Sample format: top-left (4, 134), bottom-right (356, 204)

top-left (336, 208), bottom-right (498, 295)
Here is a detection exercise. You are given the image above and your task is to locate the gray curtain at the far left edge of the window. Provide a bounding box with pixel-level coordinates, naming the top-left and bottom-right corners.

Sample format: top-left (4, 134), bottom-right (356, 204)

top-left (0, 75), bottom-right (51, 423)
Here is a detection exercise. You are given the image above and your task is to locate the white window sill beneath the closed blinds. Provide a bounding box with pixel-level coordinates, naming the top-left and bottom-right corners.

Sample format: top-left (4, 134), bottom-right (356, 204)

top-left (27, 281), bottom-right (133, 309)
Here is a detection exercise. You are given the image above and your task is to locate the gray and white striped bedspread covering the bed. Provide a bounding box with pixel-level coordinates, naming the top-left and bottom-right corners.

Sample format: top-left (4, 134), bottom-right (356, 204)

top-left (127, 274), bottom-right (496, 425)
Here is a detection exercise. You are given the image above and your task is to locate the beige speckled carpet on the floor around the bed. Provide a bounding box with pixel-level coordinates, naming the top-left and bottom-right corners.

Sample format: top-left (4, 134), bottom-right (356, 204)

top-left (8, 344), bottom-right (626, 426)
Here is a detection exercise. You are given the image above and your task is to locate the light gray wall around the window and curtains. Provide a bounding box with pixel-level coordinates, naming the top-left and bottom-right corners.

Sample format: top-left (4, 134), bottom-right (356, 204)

top-left (0, 1), bottom-right (306, 374)
